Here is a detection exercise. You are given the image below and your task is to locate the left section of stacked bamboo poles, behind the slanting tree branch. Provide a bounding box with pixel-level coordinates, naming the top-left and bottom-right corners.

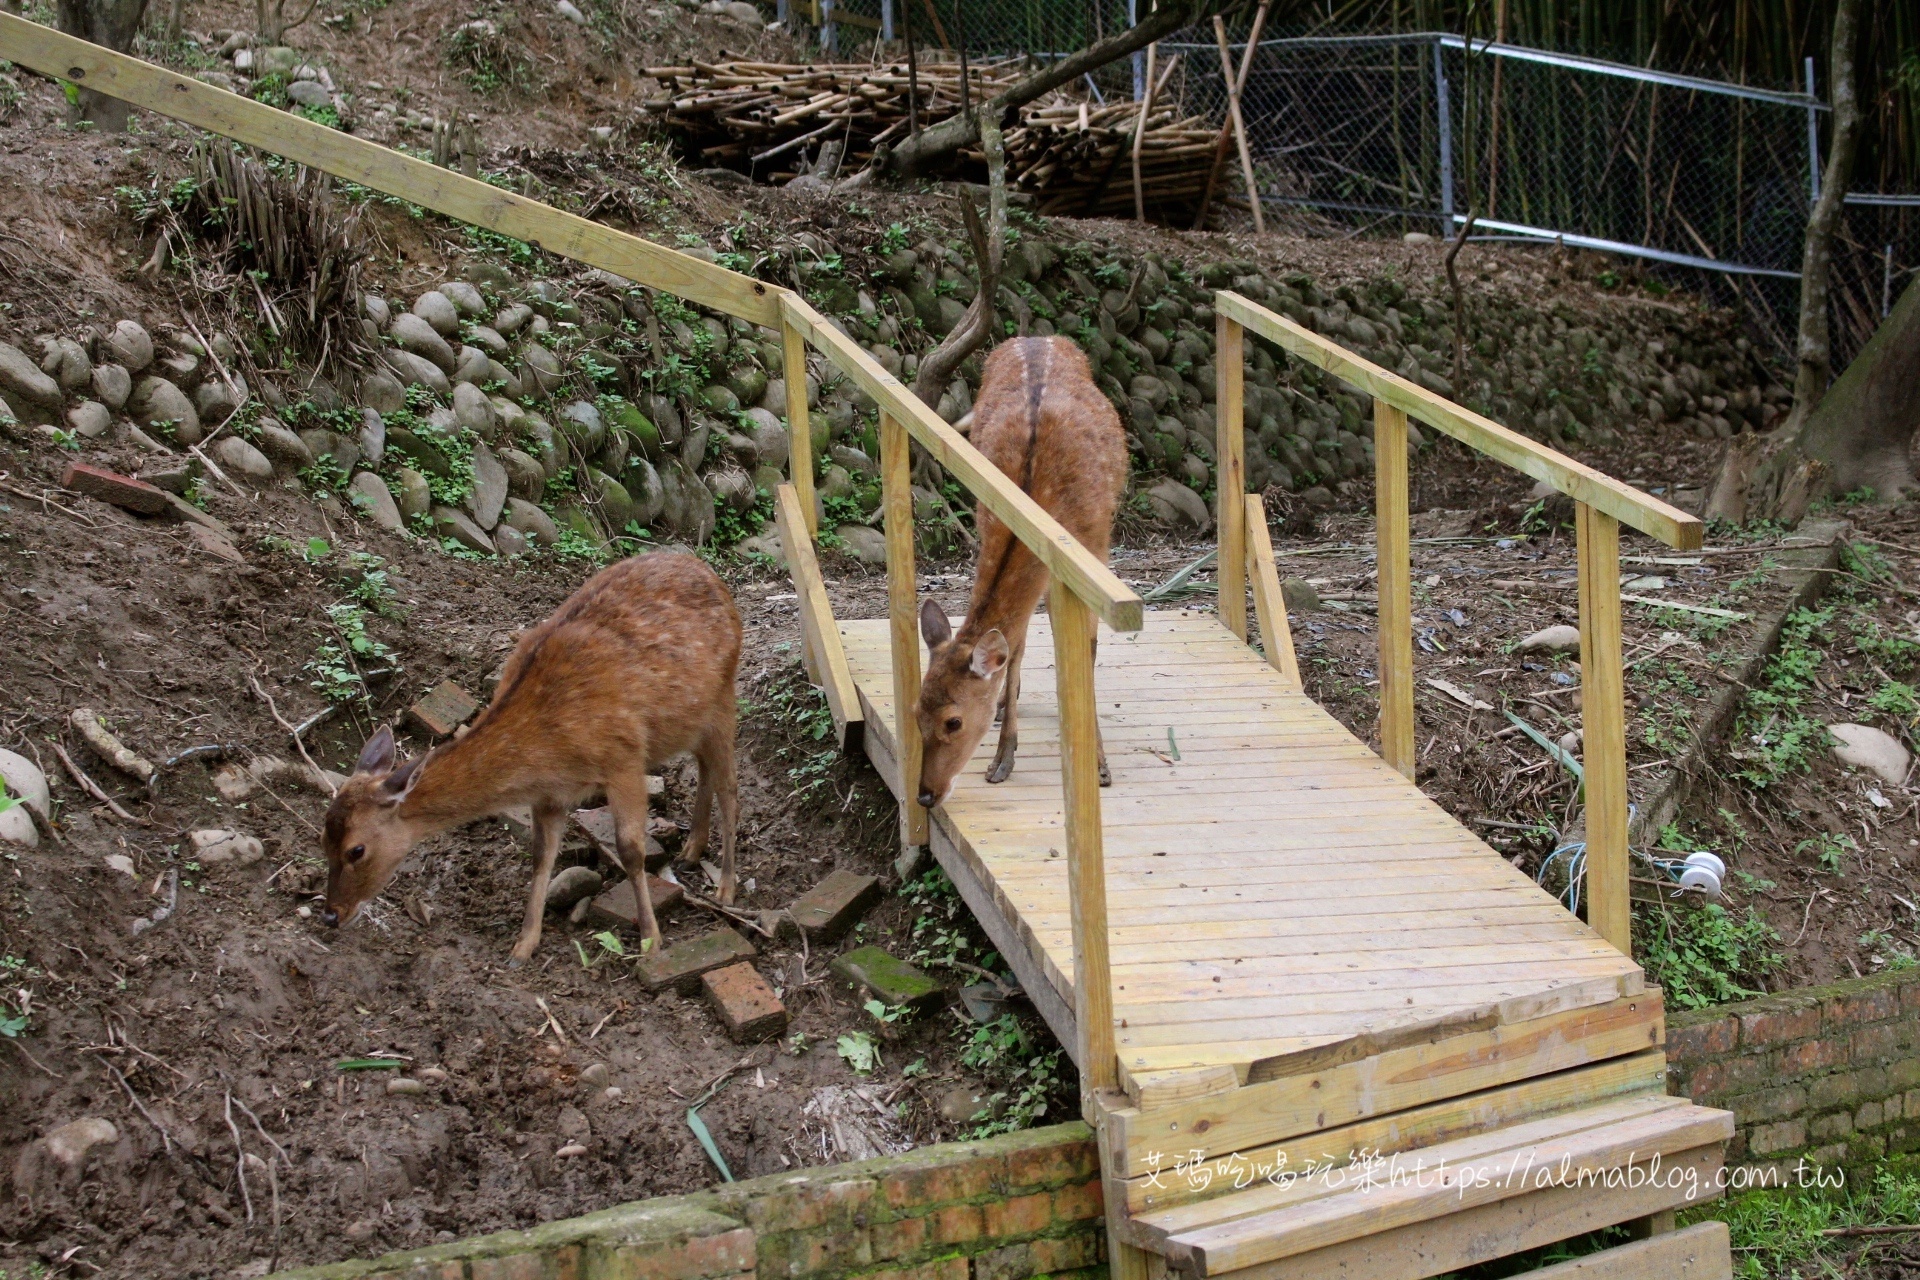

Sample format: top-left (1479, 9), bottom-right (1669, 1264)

top-left (643, 58), bottom-right (1021, 173)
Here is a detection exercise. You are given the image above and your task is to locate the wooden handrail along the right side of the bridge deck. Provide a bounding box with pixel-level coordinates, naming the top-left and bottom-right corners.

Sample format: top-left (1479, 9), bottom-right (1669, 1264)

top-left (1213, 292), bottom-right (1701, 551)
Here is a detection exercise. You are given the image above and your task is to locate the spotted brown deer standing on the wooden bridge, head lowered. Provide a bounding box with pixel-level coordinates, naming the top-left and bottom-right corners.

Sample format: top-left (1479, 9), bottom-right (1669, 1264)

top-left (914, 338), bottom-right (1127, 808)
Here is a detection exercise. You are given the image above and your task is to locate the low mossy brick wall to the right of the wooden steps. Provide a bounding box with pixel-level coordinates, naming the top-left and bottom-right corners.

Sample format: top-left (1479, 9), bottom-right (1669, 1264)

top-left (1667, 971), bottom-right (1920, 1167)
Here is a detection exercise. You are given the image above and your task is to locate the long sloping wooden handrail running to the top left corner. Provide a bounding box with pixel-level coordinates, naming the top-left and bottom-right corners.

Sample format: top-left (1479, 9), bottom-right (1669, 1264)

top-left (0, 13), bottom-right (783, 326)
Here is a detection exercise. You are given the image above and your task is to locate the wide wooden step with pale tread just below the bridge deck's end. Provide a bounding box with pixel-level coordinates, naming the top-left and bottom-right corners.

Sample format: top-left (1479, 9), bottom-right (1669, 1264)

top-left (1127, 1096), bottom-right (1734, 1280)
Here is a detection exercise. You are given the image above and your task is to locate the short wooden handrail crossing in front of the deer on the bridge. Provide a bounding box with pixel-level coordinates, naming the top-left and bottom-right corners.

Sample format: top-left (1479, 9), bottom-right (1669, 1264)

top-left (780, 292), bottom-right (1142, 631)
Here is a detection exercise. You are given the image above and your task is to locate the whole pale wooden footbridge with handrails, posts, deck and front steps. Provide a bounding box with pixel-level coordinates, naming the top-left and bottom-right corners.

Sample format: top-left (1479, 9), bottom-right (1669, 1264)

top-left (0, 13), bottom-right (1732, 1280)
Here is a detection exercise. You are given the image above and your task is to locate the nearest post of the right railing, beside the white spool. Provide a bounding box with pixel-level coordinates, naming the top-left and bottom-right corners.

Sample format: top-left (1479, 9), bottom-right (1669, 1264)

top-left (1574, 503), bottom-right (1634, 956)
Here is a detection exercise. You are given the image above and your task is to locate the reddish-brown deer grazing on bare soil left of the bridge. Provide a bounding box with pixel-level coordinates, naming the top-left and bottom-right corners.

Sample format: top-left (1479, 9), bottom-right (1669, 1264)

top-left (321, 551), bottom-right (741, 965)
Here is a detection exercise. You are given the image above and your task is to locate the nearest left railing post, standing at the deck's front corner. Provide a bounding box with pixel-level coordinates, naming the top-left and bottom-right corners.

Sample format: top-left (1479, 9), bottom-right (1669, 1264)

top-left (1046, 581), bottom-right (1119, 1125)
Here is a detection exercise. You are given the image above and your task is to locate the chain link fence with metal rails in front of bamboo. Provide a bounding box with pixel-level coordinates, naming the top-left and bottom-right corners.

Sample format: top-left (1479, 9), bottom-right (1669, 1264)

top-left (1164, 33), bottom-right (1920, 367)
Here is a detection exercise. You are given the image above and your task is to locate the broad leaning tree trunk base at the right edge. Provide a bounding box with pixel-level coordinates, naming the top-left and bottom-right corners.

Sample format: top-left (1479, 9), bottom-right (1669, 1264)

top-left (1799, 278), bottom-right (1920, 503)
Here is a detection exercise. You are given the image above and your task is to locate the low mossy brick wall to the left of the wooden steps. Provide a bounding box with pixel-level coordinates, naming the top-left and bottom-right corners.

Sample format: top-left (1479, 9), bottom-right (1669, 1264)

top-left (278, 1125), bottom-right (1106, 1280)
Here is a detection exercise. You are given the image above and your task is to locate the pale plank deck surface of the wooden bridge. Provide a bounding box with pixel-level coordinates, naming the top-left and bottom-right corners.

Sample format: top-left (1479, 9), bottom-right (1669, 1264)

top-left (837, 610), bottom-right (1657, 1092)
